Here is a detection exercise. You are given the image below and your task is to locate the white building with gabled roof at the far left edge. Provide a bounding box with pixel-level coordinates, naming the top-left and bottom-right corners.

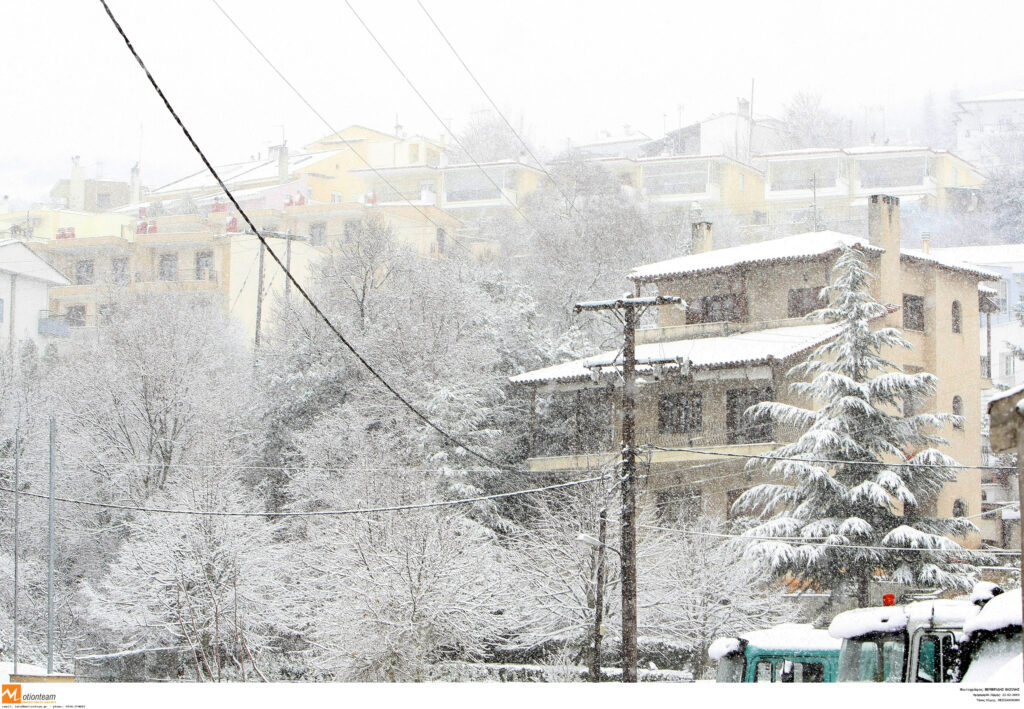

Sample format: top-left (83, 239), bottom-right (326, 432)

top-left (0, 239), bottom-right (71, 350)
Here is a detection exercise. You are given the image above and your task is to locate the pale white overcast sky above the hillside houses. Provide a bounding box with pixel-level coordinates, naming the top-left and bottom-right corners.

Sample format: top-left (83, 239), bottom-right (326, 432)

top-left (0, 0), bottom-right (1024, 204)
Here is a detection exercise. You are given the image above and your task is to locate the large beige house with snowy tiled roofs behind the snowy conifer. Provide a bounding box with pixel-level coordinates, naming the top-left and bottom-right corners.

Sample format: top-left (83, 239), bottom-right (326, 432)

top-left (512, 196), bottom-right (996, 532)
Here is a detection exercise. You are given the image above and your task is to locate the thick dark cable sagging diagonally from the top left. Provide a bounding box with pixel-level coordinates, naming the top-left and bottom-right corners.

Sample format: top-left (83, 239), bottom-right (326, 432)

top-left (99, 0), bottom-right (516, 470)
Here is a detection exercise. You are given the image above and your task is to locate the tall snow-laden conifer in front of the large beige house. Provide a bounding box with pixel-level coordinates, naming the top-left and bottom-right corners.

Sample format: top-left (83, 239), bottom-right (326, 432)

top-left (734, 248), bottom-right (980, 606)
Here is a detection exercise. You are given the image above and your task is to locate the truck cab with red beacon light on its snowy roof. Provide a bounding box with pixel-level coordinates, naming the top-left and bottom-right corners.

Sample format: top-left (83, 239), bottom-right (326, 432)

top-left (828, 596), bottom-right (979, 683)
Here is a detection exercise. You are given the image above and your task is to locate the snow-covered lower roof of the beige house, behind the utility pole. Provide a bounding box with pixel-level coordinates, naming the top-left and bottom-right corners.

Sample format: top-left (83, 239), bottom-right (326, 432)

top-left (510, 324), bottom-right (843, 384)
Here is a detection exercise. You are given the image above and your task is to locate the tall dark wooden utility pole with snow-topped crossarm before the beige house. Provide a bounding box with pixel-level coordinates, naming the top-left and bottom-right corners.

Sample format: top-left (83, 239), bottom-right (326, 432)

top-left (573, 294), bottom-right (682, 682)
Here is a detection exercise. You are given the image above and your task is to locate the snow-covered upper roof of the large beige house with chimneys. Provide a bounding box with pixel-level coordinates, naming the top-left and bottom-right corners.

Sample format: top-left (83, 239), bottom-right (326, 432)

top-left (627, 232), bottom-right (885, 281)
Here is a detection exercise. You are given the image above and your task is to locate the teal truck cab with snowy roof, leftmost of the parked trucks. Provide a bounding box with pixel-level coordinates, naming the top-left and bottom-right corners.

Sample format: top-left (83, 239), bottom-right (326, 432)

top-left (708, 623), bottom-right (842, 683)
